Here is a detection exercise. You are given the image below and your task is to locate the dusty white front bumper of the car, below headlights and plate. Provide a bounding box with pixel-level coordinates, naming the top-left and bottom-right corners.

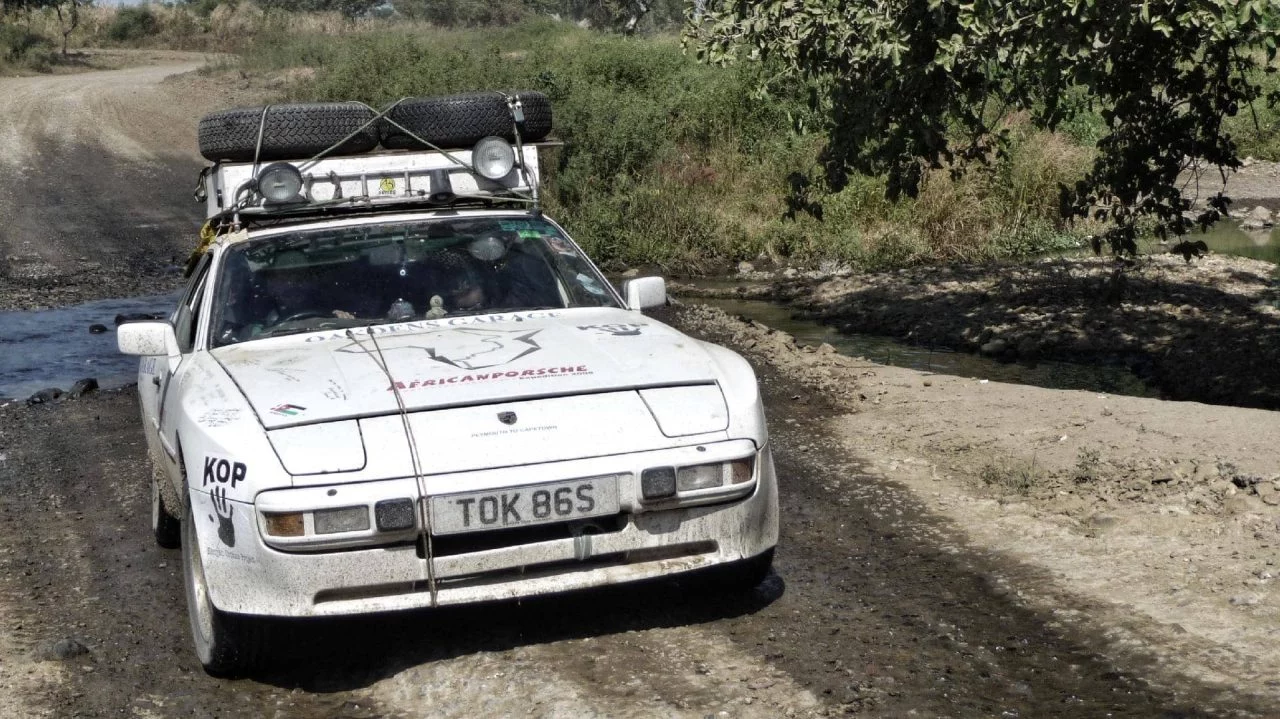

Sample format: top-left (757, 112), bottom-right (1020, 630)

top-left (192, 446), bottom-right (778, 617)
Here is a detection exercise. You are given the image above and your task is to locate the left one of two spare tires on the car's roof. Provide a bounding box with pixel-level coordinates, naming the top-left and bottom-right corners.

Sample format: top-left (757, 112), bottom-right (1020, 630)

top-left (198, 102), bottom-right (378, 162)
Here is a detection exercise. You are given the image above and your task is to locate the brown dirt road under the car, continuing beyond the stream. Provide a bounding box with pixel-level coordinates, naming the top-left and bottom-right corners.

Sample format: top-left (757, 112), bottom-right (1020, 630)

top-left (0, 53), bottom-right (1280, 718)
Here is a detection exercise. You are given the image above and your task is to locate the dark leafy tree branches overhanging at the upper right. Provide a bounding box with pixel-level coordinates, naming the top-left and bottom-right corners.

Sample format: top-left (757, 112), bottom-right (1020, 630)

top-left (685, 0), bottom-right (1280, 252)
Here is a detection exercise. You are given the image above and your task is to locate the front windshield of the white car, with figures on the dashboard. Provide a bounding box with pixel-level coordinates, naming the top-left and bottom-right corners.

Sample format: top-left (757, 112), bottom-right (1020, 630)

top-left (212, 217), bottom-right (618, 347)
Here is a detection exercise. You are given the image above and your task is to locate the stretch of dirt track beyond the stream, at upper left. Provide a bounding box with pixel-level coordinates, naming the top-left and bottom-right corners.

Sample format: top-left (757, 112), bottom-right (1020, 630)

top-left (0, 58), bottom-right (218, 310)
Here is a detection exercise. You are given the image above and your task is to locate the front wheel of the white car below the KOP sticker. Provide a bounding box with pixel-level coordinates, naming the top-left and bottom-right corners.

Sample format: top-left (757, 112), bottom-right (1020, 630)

top-left (182, 502), bottom-right (269, 677)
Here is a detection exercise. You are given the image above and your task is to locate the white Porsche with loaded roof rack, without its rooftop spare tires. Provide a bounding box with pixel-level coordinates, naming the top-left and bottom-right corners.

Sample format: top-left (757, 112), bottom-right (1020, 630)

top-left (119, 96), bottom-right (778, 673)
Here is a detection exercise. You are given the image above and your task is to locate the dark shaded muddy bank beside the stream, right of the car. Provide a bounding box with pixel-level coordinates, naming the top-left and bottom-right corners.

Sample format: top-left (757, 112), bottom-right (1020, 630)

top-left (676, 253), bottom-right (1280, 409)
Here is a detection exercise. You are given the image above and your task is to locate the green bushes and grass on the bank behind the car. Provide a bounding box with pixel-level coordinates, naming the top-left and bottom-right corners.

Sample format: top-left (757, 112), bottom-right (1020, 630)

top-left (246, 20), bottom-right (1088, 271)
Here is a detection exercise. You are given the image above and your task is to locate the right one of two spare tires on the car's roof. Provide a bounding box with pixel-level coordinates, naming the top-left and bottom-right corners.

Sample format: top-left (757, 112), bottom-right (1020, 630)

top-left (381, 90), bottom-right (552, 150)
